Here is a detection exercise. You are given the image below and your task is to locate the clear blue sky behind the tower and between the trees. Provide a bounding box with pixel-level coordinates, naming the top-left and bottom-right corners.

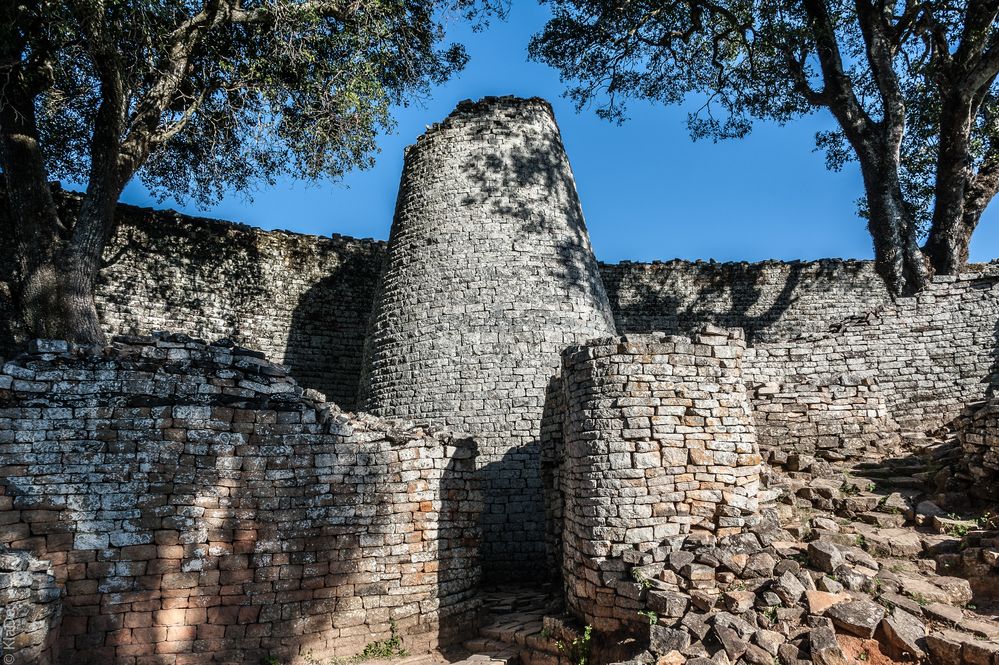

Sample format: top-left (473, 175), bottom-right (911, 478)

top-left (105, 1), bottom-right (999, 261)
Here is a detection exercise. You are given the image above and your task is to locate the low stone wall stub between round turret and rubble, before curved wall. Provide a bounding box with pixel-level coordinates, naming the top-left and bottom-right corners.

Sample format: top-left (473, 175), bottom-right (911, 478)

top-left (750, 374), bottom-right (901, 460)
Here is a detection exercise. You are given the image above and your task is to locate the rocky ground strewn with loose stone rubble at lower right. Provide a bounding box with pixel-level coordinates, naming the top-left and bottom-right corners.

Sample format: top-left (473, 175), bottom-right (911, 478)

top-left (449, 438), bottom-right (999, 665)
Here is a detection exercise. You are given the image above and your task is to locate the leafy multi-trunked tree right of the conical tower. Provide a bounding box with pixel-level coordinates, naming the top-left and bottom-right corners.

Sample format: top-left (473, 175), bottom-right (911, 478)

top-left (530, 0), bottom-right (999, 294)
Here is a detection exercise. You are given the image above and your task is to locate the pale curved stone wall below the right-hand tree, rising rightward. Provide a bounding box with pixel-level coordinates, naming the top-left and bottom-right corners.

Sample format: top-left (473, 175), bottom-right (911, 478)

top-left (743, 267), bottom-right (999, 431)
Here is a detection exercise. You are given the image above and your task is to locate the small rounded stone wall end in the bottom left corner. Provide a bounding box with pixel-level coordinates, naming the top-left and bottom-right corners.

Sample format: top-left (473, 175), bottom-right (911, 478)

top-left (0, 544), bottom-right (62, 665)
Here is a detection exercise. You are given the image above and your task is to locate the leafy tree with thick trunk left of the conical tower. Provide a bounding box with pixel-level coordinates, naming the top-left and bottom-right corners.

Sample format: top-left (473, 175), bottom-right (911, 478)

top-left (0, 0), bottom-right (502, 343)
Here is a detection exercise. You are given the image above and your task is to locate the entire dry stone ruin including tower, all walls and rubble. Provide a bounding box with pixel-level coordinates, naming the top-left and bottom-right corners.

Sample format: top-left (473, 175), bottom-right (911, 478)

top-left (0, 97), bottom-right (999, 665)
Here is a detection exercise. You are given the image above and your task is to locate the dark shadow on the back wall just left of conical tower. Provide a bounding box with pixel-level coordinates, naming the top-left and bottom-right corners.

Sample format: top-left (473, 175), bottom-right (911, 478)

top-left (284, 252), bottom-right (382, 411)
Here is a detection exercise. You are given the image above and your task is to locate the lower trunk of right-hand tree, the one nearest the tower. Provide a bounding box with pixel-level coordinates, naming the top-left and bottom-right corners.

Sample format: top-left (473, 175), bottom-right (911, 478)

top-left (862, 161), bottom-right (929, 296)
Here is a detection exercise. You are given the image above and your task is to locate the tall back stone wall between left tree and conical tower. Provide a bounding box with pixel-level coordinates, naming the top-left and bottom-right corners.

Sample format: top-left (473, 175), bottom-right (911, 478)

top-left (0, 192), bottom-right (385, 409)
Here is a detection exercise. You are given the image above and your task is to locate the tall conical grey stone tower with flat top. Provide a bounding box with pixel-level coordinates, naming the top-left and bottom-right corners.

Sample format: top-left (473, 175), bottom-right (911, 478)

top-left (360, 97), bottom-right (615, 580)
